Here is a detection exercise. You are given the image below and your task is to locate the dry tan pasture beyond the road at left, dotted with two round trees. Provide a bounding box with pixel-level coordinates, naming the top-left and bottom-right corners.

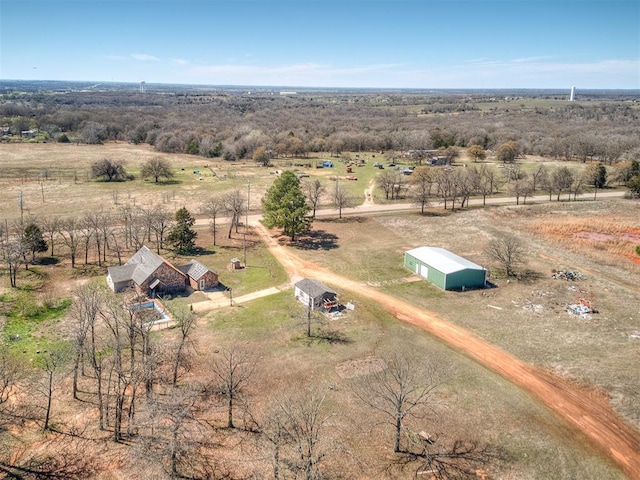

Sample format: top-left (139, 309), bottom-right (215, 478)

top-left (0, 143), bottom-right (272, 220)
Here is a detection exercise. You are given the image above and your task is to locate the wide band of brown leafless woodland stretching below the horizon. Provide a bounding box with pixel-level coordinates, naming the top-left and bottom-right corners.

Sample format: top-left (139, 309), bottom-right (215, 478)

top-left (0, 92), bottom-right (640, 165)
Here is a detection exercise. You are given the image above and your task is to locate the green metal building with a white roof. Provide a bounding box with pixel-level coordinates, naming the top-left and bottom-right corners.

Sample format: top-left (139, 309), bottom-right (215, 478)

top-left (404, 247), bottom-right (487, 290)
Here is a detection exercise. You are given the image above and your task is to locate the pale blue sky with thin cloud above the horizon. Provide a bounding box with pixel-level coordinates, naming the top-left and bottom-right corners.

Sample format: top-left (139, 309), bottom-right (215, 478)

top-left (0, 0), bottom-right (640, 89)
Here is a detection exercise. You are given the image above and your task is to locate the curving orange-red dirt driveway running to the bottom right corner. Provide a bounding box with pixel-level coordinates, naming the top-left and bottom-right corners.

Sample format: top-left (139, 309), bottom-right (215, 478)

top-left (254, 223), bottom-right (640, 479)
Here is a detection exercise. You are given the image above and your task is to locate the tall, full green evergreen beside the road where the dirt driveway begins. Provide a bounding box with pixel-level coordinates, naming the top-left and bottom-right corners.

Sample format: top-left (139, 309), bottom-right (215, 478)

top-left (262, 171), bottom-right (312, 241)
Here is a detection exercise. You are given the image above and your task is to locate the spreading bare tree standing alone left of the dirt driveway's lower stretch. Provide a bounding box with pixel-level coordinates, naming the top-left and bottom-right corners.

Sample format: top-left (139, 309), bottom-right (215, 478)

top-left (353, 354), bottom-right (445, 453)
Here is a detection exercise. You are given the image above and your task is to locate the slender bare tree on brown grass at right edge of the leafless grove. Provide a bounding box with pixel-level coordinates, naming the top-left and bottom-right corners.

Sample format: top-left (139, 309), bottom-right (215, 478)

top-left (211, 346), bottom-right (253, 428)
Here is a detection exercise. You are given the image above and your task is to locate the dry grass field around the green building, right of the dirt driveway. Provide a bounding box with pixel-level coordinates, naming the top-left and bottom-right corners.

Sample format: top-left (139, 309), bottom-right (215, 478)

top-left (292, 200), bottom-right (640, 436)
